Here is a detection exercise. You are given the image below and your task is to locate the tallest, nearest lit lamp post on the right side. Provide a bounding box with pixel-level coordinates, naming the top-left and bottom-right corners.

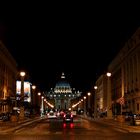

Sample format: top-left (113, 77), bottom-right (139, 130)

top-left (106, 72), bottom-right (112, 118)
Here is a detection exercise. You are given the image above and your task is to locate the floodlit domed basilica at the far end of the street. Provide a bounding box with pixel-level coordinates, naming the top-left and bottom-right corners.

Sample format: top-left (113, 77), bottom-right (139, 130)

top-left (46, 73), bottom-right (81, 110)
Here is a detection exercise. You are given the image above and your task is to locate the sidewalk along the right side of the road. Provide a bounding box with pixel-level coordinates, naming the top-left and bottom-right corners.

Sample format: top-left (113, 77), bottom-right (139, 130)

top-left (80, 116), bottom-right (140, 133)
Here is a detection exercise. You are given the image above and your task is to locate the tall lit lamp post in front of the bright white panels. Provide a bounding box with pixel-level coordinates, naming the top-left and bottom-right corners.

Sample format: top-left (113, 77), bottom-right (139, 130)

top-left (19, 71), bottom-right (25, 120)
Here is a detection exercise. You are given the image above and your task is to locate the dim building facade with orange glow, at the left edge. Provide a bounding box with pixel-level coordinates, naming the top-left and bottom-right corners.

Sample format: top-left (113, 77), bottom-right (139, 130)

top-left (0, 41), bottom-right (17, 113)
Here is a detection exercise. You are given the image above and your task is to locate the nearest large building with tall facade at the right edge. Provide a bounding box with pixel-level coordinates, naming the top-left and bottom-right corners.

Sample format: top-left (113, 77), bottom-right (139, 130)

top-left (108, 28), bottom-right (140, 114)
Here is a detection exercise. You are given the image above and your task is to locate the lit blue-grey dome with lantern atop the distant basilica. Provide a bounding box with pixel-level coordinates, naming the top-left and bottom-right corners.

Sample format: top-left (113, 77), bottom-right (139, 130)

top-left (54, 73), bottom-right (72, 93)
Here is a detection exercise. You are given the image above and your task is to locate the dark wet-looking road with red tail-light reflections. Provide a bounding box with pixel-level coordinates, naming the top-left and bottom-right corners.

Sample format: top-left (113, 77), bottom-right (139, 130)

top-left (0, 118), bottom-right (140, 140)
